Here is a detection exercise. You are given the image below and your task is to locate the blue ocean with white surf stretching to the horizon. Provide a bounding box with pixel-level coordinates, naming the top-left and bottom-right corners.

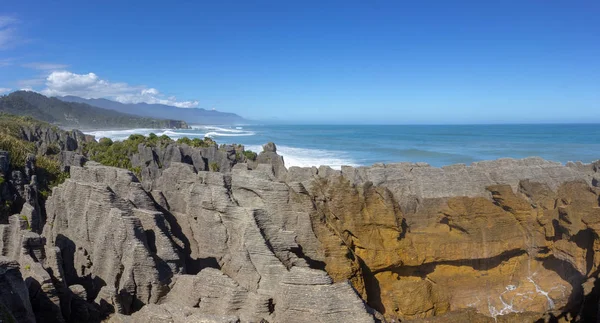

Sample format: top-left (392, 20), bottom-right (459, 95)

top-left (87, 124), bottom-right (600, 169)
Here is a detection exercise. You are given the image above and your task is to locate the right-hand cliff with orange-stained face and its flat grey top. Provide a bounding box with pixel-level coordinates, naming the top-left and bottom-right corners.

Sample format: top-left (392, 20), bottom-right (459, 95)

top-left (308, 159), bottom-right (600, 320)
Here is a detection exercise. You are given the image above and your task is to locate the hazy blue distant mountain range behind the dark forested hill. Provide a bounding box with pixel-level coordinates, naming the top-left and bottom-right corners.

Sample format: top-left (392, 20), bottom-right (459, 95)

top-left (58, 96), bottom-right (250, 125)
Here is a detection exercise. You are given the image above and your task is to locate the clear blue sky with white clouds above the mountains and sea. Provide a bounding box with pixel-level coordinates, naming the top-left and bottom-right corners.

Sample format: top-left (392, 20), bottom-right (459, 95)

top-left (0, 0), bottom-right (600, 124)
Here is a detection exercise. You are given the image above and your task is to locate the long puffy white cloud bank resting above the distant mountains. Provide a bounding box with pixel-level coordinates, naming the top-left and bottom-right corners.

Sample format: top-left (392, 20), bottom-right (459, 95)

top-left (41, 71), bottom-right (198, 108)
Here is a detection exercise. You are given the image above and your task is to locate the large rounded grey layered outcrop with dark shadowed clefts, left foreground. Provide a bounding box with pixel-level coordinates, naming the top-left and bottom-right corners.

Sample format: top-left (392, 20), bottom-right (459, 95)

top-left (44, 163), bottom-right (183, 314)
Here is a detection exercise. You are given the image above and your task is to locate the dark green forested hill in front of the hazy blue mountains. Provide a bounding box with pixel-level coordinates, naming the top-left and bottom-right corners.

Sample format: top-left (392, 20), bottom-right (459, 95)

top-left (0, 91), bottom-right (188, 129)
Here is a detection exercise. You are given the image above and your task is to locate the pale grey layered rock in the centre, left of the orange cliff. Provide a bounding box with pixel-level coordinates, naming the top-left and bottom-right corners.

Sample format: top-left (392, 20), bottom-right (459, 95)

top-left (146, 163), bottom-right (372, 322)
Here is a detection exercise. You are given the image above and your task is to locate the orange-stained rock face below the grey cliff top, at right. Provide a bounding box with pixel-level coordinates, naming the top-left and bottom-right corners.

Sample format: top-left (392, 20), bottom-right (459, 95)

top-left (310, 176), bottom-right (600, 322)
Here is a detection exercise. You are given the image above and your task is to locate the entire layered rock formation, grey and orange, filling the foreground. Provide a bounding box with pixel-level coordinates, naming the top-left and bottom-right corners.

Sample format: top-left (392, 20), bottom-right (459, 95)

top-left (0, 117), bottom-right (600, 323)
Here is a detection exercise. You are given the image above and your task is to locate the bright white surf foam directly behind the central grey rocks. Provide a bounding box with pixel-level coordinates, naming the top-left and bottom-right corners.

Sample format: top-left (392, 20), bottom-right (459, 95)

top-left (245, 145), bottom-right (359, 170)
